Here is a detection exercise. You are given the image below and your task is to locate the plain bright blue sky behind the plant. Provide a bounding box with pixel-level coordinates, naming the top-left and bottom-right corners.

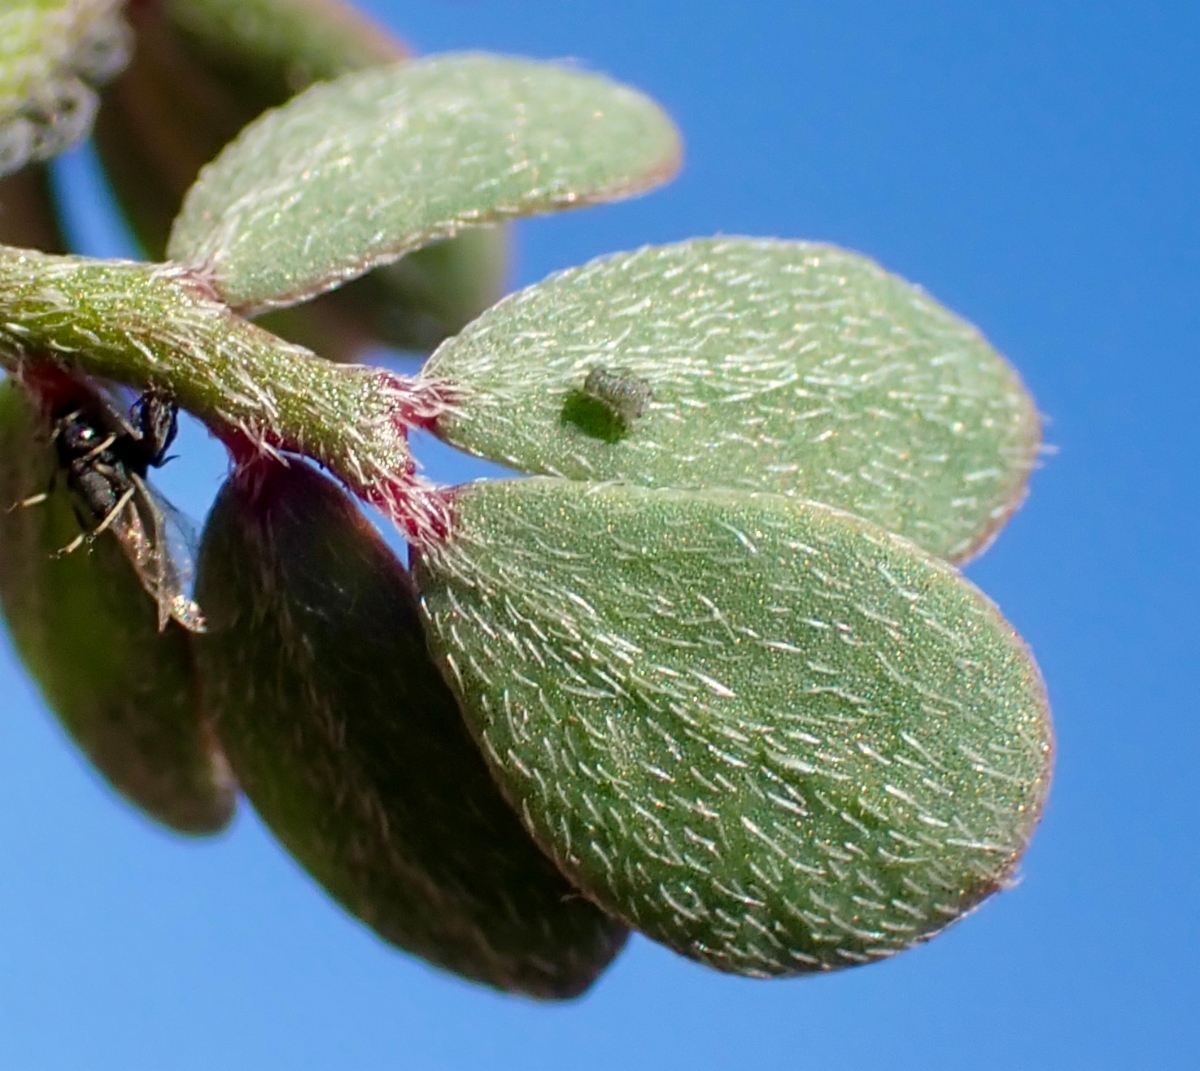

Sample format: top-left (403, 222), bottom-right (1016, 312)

top-left (0, 0), bottom-right (1200, 1071)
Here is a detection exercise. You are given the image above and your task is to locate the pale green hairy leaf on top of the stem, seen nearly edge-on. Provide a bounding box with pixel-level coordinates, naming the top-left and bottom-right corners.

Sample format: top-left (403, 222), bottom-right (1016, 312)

top-left (168, 55), bottom-right (679, 312)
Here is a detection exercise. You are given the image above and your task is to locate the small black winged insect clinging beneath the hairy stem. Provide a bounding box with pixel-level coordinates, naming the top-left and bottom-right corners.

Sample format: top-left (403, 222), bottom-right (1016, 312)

top-left (23, 390), bottom-right (204, 632)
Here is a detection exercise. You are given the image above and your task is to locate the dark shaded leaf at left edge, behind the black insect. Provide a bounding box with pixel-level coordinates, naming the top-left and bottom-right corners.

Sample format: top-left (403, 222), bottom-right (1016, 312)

top-left (0, 379), bottom-right (235, 833)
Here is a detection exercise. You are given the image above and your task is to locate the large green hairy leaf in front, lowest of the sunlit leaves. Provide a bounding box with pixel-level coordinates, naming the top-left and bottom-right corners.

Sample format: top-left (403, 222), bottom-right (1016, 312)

top-left (415, 478), bottom-right (1051, 976)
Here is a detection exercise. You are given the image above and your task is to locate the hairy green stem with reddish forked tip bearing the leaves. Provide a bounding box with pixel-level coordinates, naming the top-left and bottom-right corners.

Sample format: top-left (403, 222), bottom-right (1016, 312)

top-left (0, 246), bottom-right (451, 546)
